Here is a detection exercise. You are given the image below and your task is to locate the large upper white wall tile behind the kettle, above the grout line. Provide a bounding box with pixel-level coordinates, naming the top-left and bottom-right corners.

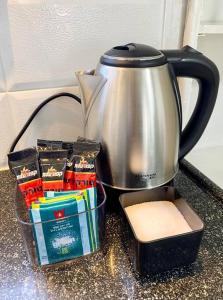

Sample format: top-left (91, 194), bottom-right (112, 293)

top-left (0, 0), bottom-right (171, 91)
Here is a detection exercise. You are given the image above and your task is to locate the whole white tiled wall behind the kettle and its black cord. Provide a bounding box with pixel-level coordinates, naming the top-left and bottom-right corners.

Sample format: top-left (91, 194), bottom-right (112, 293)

top-left (0, 0), bottom-right (187, 167)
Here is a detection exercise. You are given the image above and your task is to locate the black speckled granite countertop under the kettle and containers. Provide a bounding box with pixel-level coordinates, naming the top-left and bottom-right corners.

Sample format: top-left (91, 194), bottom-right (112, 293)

top-left (0, 164), bottom-right (223, 300)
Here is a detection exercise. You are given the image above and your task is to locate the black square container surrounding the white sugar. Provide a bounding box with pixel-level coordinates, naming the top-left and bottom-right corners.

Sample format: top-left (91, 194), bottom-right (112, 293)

top-left (119, 186), bottom-right (204, 275)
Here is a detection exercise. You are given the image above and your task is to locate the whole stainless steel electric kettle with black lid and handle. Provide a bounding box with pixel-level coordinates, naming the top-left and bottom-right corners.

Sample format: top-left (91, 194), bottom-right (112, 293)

top-left (76, 43), bottom-right (219, 190)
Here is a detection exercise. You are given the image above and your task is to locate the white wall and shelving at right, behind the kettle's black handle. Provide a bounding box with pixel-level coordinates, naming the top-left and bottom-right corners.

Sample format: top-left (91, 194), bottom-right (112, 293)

top-left (186, 0), bottom-right (223, 188)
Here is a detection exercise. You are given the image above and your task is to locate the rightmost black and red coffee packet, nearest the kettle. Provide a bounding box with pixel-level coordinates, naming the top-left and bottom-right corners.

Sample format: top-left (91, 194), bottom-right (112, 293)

top-left (73, 141), bottom-right (100, 190)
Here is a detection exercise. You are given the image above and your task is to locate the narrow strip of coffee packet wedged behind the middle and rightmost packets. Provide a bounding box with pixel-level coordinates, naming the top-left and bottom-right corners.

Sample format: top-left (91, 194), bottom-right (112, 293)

top-left (62, 142), bottom-right (74, 191)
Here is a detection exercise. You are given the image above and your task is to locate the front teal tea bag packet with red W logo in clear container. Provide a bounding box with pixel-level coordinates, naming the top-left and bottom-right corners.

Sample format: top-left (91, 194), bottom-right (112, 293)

top-left (30, 191), bottom-right (97, 265)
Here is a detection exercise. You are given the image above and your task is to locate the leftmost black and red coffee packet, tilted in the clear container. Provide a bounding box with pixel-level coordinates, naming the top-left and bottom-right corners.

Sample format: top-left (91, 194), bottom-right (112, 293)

top-left (8, 148), bottom-right (43, 208)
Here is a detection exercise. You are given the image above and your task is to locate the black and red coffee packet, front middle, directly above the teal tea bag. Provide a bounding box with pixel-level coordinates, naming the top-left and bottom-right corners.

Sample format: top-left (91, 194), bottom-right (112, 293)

top-left (39, 150), bottom-right (67, 191)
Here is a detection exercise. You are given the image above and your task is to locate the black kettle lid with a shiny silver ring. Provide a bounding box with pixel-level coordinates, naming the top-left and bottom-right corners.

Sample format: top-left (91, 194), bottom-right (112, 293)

top-left (100, 43), bottom-right (166, 68)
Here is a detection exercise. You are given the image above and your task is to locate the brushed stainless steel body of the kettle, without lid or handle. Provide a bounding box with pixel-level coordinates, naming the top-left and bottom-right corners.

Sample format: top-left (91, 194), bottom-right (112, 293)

top-left (77, 42), bottom-right (219, 189)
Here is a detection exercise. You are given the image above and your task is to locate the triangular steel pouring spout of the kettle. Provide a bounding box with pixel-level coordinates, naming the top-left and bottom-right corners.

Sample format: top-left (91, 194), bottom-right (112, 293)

top-left (75, 70), bottom-right (107, 121)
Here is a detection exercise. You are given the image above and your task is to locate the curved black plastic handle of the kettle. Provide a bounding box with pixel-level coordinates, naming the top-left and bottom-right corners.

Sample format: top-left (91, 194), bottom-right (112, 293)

top-left (162, 46), bottom-right (219, 159)
